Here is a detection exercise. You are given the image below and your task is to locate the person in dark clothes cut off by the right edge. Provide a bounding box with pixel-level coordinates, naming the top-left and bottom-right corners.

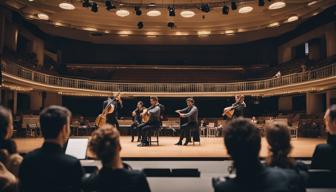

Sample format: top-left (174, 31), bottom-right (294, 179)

top-left (311, 105), bottom-right (336, 171)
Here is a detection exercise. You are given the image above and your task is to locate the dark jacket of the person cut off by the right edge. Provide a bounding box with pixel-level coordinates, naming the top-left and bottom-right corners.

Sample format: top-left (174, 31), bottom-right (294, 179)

top-left (311, 135), bottom-right (336, 171)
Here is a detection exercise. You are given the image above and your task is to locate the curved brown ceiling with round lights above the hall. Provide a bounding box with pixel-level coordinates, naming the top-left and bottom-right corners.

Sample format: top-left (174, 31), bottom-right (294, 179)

top-left (0, 0), bottom-right (336, 44)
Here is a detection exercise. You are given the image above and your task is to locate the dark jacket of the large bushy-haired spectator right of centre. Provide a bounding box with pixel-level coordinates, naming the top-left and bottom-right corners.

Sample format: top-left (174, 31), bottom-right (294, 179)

top-left (213, 166), bottom-right (305, 192)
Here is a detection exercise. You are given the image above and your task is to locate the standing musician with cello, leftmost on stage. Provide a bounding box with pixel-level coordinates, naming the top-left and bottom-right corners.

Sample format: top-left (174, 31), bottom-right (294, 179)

top-left (103, 93), bottom-right (123, 129)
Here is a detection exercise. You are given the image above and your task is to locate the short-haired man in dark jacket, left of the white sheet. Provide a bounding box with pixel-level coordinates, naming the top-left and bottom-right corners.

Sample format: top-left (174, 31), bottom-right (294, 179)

top-left (19, 105), bottom-right (83, 192)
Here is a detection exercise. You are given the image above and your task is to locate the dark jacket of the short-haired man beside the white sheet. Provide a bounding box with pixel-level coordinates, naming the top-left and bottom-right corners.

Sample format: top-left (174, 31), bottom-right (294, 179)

top-left (19, 143), bottom-right (83, 192)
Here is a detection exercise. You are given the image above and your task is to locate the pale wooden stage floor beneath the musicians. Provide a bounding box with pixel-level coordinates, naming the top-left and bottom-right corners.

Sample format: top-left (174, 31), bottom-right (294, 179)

top-left (15, 136), bottom-right (325, 159)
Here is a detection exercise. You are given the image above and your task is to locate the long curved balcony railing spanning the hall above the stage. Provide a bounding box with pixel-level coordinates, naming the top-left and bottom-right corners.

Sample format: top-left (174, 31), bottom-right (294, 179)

top-left (3, 61), bottom-right (336, 93)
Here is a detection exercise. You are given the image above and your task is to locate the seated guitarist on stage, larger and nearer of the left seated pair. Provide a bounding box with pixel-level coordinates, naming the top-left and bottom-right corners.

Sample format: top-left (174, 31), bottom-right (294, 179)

top-left (138, 97), bottom-right (161, 147)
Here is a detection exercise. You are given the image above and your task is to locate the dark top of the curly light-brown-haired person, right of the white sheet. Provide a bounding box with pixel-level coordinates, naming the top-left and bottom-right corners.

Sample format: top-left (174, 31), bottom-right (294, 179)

top-left (83, 167), bottom-right (150, 192)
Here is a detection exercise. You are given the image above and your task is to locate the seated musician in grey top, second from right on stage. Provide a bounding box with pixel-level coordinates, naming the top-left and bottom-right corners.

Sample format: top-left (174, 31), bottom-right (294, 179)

top-left (175, 98), bottom-right (198, 145)
